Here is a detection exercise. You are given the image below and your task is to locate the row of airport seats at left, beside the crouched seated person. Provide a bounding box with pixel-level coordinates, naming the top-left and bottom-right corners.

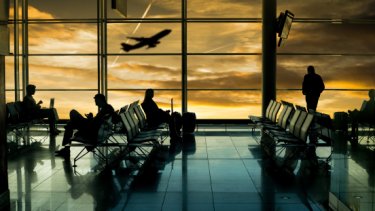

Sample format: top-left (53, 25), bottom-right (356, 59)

top-left (70, 101), bottom-right (168, 171)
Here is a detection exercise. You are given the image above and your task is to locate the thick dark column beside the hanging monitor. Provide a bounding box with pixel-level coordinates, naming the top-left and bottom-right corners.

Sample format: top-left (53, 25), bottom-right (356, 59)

top-left (262, 0), bottom-right (276, 116)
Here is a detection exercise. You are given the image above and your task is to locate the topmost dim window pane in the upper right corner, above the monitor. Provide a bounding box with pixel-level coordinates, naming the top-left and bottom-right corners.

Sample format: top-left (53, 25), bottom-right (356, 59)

top-left (277, 0), bottom-right (374, 19)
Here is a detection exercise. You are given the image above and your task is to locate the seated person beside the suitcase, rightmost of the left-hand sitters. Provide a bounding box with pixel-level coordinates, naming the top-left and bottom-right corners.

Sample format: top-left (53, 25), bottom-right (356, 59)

top-left (141, 89), bottom-right (171, 128)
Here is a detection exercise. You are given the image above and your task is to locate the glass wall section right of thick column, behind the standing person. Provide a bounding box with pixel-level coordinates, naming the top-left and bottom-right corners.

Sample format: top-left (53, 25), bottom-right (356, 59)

top-left (277, 0), bottom-right (375, 116)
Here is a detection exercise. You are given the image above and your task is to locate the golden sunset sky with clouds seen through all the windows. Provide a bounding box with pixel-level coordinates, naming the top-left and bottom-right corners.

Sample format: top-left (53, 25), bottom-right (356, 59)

top-left (6, 0), bottom-right (375, 119)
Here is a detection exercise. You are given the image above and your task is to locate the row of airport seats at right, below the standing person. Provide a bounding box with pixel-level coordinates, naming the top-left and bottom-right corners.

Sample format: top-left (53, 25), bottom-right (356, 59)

top-left (249, 100), bottom-right (333, 162)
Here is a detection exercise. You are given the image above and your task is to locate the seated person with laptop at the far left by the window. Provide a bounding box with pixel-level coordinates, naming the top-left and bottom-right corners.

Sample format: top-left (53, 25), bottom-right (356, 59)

top-left (22, 84), bottom-right (60, 135)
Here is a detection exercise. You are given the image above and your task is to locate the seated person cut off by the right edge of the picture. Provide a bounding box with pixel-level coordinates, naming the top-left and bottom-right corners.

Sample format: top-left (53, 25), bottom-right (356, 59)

top-left (348, 89), bottom-right (375, 140)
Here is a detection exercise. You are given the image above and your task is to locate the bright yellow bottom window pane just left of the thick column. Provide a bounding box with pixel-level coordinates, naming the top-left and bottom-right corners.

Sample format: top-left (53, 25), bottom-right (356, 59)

top-left (188, 91), bottom-right (262, 119)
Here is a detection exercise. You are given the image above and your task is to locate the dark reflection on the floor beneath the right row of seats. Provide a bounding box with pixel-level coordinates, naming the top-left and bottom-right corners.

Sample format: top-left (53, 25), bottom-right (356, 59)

top-left (252, 135), bottom-right (330, 210)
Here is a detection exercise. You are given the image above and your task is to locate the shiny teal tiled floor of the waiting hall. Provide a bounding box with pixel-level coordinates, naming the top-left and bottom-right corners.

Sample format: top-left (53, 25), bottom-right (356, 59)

top-left (8, 125), bottom-right (375, 211)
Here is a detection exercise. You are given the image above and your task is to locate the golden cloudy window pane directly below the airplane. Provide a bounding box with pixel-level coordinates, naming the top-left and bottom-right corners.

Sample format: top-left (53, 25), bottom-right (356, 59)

top-left (108, 56), bottom-right (181, 89)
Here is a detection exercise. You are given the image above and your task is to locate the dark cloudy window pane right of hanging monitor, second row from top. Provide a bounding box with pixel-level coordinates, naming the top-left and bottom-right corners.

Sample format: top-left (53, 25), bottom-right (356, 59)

top-left (278, 23), bottom-right (375, 54)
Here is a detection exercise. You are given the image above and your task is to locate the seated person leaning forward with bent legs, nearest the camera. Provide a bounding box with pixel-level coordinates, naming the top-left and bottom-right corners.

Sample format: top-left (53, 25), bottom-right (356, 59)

top-left (56, 94), bottom-right (115, 157)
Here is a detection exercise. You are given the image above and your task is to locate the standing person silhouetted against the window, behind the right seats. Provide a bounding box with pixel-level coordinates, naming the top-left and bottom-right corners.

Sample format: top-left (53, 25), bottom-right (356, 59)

top-left (302, 65), bottom-right (325, 111)
